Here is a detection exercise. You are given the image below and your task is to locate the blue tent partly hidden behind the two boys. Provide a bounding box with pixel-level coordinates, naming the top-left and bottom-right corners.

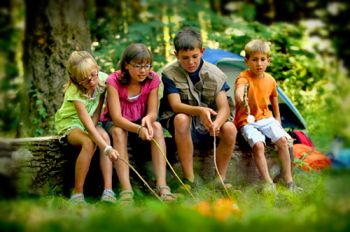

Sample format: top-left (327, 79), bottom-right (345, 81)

top-left (203, 48), bottom-right (306, 130)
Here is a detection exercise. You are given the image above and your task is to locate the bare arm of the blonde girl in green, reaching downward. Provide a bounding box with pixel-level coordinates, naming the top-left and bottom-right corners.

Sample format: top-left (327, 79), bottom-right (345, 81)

top-left (74, 98), bottom-right (119, 160)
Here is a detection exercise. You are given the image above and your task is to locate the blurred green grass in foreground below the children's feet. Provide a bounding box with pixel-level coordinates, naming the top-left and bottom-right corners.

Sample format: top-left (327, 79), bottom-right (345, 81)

top-left (0, 170), bottom-right (350, 232)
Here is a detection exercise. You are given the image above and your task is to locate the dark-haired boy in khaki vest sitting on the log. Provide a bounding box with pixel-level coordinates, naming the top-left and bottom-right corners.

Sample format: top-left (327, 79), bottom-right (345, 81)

top-left (159, 28), bottom-right (237, 187)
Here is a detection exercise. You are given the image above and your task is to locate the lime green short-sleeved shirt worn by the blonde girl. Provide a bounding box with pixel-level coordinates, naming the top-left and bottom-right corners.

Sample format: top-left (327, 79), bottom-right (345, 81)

top-left (55, 72), bottom-right (108, 135)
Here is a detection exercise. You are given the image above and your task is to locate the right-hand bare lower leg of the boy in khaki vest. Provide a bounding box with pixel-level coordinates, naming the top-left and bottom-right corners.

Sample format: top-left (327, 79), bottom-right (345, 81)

top-left (216, 122), bottom-right (237, 180)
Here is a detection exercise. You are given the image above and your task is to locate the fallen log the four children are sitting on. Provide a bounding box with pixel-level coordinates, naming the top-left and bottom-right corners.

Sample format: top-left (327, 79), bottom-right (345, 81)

top-left (0, 136), bottom-right (280, 197)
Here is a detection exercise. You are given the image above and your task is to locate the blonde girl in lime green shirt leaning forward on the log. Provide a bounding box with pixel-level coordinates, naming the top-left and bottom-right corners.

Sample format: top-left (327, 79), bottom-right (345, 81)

top-left (55, 51), bottom-right (119, 203)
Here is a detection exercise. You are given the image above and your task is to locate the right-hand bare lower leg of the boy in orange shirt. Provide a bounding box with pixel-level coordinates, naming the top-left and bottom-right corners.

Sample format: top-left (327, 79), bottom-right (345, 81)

top-left (276, 137), bottom-right (293, 183)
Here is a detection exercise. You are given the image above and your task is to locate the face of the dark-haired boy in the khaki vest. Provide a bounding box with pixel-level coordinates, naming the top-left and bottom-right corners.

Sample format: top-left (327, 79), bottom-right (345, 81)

top-left (175, 48), bottom-right (204, 73)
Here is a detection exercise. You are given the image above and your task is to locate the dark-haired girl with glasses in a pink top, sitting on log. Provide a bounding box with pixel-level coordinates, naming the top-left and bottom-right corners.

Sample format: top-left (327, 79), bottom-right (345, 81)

top-left (101, 43), bottom-right (175, 203)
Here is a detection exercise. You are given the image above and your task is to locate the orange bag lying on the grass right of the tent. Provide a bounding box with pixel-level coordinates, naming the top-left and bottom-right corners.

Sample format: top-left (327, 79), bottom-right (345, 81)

top-left (293, 144), bottom-right (331, 171)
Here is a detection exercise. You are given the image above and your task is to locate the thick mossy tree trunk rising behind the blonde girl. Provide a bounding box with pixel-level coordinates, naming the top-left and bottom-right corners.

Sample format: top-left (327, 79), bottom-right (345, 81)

top-left (22, 0), bottom-right (91, 136)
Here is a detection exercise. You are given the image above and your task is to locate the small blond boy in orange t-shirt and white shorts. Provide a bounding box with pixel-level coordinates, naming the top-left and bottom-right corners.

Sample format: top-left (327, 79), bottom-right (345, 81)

top-left (234, 40), bottom-right (297, 192)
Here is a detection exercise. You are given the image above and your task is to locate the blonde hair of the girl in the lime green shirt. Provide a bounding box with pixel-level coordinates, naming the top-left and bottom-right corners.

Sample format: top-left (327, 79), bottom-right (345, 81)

top-left (64, 51), bottom-right (99, 93)
